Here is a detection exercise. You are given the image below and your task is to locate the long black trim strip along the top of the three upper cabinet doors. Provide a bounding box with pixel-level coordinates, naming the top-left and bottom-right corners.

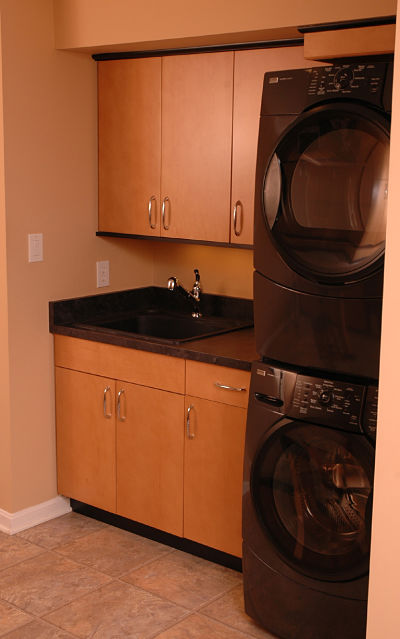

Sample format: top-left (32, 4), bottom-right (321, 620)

top-left (92, 37), bottom-right (303, 62)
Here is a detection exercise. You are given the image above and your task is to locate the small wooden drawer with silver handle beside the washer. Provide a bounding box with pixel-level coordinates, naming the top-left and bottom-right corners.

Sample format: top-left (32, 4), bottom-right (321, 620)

top-left (186, 360), bottom-right (250, 408)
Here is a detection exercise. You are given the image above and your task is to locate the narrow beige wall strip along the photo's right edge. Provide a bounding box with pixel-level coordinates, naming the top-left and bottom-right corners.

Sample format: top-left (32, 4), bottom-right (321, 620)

top-left (367, 16), bottom-right (400, 639)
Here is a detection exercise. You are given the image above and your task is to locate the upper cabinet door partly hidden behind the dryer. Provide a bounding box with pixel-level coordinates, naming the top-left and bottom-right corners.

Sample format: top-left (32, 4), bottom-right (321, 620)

top-left (231, 47), bottom-right (315, 244)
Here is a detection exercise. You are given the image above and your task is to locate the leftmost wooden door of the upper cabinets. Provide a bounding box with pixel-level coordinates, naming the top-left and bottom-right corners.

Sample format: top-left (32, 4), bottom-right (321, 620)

top-left (98, 58), bottom-right (161, 235)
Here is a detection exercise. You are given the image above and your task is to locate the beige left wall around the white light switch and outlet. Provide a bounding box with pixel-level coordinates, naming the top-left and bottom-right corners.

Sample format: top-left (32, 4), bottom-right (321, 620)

top-left (0, 0), bottom-right (153, 512)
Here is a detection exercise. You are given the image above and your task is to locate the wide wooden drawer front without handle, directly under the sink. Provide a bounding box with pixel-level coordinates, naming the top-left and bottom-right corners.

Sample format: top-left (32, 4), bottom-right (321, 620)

top-left (54, 335), bottom-right (185, 395)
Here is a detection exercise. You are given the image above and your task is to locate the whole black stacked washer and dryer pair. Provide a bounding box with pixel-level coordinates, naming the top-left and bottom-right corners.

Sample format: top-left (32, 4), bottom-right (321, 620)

top-left (243, 59), bottom-right (392, 639)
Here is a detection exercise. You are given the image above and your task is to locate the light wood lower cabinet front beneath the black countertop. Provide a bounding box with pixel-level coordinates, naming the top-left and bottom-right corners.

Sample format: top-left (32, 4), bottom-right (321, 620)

top-left (55, 335), bottom-right (250, 556)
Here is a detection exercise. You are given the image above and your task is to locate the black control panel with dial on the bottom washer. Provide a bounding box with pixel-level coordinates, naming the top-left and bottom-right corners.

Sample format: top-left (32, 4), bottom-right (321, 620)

top-left (288, 375), bottom-right (365, 431)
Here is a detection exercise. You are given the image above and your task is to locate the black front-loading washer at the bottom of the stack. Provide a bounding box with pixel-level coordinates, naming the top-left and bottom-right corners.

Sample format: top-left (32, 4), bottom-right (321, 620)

top-left (243, 362), bottom-right (378, 639)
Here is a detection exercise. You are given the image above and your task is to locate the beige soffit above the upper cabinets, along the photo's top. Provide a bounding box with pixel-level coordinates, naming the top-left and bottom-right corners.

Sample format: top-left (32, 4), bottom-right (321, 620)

top-left (55, 0), bottom-right (396, 50)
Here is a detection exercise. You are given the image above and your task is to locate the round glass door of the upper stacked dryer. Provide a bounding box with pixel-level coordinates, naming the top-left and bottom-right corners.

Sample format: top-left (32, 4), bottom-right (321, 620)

top-left (262, 102), bottom-right (389, 283)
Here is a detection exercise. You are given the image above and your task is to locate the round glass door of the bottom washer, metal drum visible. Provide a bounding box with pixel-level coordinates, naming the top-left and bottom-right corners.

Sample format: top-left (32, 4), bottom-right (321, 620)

top-left (250, 421), bottom-right (374, 581)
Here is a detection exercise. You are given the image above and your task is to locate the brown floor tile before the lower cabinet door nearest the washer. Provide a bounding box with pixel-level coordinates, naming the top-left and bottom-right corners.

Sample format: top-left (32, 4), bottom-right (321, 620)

top-left (123, 550), bottom-right (241, 610)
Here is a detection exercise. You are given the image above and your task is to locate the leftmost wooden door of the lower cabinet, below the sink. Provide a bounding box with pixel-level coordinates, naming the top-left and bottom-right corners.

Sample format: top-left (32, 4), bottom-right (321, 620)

top-left (56, 367), bottom-right (116, 512)
